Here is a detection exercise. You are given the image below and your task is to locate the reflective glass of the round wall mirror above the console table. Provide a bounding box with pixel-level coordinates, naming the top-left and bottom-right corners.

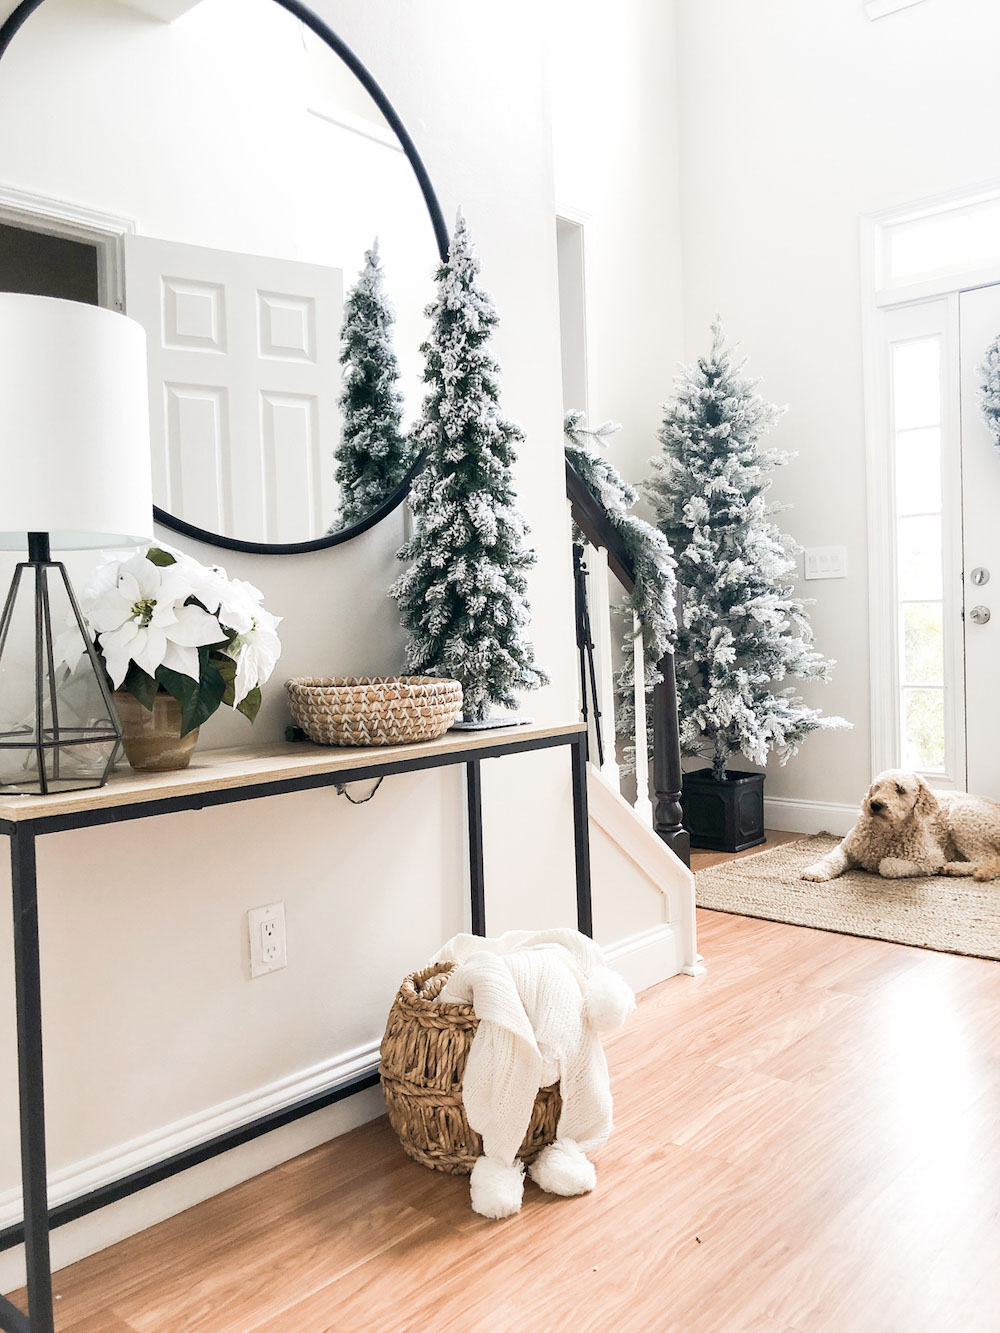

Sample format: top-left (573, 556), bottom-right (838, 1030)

top-left (0, 0), bottom-right (437, 544)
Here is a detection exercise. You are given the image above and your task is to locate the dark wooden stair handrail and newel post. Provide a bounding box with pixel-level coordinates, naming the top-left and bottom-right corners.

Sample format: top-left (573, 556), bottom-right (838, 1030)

top-left (565, 459), bottom-right (691, 865)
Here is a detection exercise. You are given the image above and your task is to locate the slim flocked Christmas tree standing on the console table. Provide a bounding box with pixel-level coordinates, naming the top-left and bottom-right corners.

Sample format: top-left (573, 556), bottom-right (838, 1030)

top-left (389, 213), bottom-right (548, 721)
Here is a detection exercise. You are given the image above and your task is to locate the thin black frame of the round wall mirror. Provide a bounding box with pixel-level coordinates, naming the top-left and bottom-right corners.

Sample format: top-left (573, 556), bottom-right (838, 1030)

top-left (0, 0), bottom-right (449, 556)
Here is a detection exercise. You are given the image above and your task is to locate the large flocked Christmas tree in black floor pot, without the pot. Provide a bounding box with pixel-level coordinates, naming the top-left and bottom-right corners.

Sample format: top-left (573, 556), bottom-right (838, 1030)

top-left (644, 320), bottom-right (849, 781)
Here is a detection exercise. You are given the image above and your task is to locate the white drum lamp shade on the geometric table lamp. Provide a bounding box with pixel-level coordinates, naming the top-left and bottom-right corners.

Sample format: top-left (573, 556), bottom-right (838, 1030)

top-left (0, 292), bottom-right (153, 551)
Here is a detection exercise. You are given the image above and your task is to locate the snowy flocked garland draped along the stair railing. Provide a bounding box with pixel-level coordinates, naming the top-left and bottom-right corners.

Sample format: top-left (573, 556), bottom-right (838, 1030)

top-left (563, 412), bottom-right (677, 772)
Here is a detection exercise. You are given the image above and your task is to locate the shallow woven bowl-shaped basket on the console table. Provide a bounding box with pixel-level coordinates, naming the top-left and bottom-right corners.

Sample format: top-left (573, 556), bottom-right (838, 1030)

top-left (285, 676), bottom-right (461, 745)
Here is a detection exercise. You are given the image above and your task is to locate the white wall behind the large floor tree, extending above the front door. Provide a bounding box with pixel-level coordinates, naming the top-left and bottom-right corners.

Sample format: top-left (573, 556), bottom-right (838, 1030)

top-left (664, 0), bottom-right (1000, 804)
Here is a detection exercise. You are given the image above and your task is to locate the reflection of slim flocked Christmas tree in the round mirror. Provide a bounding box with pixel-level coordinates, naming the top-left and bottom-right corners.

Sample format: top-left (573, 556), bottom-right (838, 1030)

top-left (329, 240), bottom-right (415, 532)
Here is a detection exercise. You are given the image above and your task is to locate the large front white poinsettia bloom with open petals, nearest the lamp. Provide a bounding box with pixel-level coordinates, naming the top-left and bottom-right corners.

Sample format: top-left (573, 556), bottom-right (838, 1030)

top-left (88, 555), bottom-right (227, 689)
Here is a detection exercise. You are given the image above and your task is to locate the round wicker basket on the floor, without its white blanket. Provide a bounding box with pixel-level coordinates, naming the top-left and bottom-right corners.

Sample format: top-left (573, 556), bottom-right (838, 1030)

top-left (381, 962), bottom-right (563, 1176)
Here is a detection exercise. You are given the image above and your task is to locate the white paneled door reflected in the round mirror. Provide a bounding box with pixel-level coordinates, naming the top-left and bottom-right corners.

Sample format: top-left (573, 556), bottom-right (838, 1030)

top-left (125, 236), bottom-right (344, 543)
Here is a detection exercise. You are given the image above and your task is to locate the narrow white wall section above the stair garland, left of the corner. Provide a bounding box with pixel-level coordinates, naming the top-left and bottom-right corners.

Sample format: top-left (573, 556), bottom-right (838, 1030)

top-left (549, 0), bottom-right (683, 490)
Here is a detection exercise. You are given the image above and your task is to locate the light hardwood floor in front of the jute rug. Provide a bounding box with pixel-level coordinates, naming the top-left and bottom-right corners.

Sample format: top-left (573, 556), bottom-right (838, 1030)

top-left (9, 847), bottom-right (1000, 1333)
